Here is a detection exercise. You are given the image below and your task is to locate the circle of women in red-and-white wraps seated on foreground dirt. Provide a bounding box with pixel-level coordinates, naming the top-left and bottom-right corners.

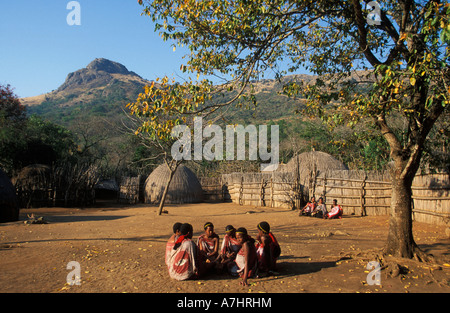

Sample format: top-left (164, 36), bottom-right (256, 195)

top-left (166, 222), bottom-right (281, 286)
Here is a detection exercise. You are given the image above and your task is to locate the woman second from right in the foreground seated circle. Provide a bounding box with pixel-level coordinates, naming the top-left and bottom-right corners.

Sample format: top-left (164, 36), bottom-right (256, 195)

top-left (228, 227), bottom-right (258, 286)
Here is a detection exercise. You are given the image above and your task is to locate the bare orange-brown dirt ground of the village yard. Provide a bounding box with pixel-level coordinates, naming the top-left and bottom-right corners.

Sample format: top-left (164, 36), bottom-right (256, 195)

top-left (0, 203), bottom-right (450, 293)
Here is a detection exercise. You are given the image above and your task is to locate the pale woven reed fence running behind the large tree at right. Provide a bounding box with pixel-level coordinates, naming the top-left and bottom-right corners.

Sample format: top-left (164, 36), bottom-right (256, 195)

top-left (200, 170), bottom-right (450, 225)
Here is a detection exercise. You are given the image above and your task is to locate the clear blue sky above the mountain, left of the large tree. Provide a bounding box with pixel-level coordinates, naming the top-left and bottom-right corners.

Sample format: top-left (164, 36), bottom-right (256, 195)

top-left (0, 0), bottom-right (186, 97)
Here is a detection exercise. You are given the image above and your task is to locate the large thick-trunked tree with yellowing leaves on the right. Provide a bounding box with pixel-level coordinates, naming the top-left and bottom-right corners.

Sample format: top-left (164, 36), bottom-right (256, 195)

top-left (134, 0), bottom-right (450, 259)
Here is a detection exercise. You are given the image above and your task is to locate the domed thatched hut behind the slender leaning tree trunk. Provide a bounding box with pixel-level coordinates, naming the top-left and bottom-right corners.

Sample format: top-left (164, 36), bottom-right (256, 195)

top-left (144, 164), bottom-right (203, 204)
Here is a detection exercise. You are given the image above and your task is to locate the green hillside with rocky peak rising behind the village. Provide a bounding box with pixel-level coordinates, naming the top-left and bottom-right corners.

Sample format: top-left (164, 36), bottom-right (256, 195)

top-left (22, 59), bottom-right (447, 176)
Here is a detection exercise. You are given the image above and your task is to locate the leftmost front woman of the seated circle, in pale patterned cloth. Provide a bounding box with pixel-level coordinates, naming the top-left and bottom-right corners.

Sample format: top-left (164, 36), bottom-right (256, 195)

top-left (167, 223), bottom-right (199, 280)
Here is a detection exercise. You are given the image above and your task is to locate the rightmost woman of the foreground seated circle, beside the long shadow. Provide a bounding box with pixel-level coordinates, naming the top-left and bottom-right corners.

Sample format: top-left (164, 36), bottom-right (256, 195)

top-left (256, 222), bottom-right (281, 274)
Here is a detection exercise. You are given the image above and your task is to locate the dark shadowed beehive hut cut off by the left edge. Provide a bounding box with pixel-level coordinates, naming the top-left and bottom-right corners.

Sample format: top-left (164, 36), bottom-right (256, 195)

top-left (0, 169), bottom-right (19, 223)
